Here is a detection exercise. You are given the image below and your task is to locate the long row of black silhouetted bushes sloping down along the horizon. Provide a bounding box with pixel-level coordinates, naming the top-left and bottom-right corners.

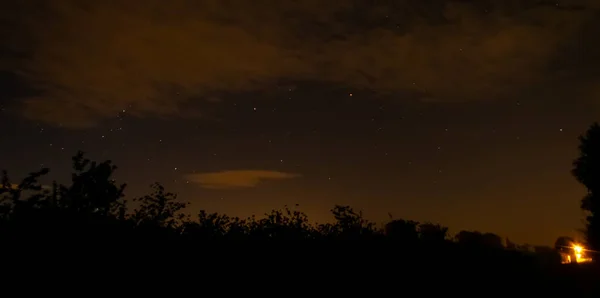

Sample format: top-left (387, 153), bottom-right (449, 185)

top-left (0, 152), bottom-right (550, 252)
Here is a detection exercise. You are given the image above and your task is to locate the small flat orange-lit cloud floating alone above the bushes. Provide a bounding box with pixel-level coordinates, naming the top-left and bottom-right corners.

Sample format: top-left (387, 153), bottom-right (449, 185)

top-left (185, 170), bottom-right (300, 189)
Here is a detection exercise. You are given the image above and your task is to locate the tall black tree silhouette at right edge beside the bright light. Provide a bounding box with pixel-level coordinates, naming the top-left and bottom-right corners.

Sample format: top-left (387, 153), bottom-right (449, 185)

top-left (572, 123), bottom-right (600, 250)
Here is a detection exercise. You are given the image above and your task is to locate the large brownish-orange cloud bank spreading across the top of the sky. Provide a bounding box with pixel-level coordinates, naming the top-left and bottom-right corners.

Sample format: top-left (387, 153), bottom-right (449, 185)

top-left (0, 0), bottom-right (599, 127)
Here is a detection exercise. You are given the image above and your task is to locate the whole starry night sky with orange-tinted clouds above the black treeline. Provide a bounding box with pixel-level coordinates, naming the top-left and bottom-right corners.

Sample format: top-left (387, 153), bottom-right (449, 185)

top-left (0, 0), bottom-right (600, 244)
